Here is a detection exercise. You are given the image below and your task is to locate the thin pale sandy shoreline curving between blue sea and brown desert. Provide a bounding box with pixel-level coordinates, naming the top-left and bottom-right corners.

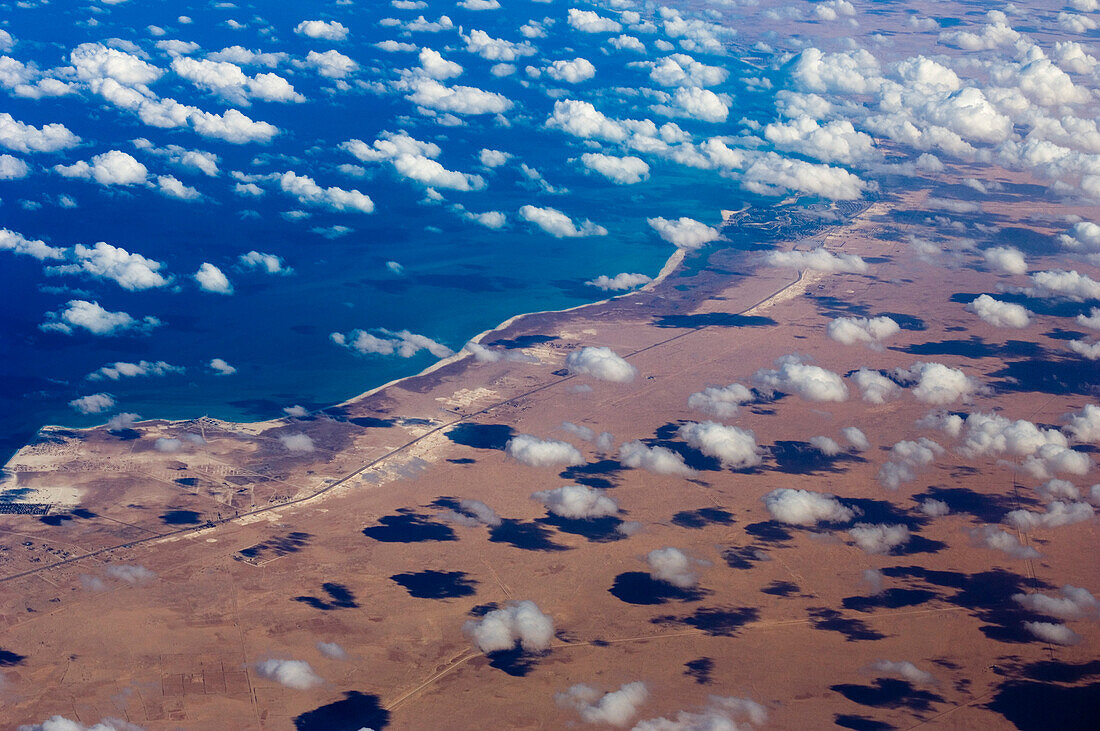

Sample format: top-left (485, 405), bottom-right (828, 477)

top-left (0, 241), bottom-right (686, 461)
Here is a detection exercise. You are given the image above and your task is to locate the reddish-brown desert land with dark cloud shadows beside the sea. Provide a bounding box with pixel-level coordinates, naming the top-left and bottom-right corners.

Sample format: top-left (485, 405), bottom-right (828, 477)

top-left (0, 169), bottom-right (1100, 729)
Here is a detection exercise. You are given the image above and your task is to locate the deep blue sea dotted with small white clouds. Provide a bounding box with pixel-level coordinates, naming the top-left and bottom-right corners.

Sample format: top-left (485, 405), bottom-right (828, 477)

top-left (0, 0), bottom-right (774, 457)
